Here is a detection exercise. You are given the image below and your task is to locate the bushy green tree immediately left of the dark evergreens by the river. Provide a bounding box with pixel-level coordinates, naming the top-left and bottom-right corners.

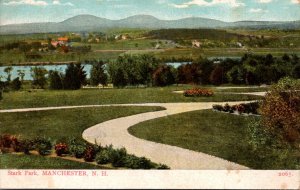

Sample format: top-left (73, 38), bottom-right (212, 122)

top-left (31, 67), bottom-right (48, 89)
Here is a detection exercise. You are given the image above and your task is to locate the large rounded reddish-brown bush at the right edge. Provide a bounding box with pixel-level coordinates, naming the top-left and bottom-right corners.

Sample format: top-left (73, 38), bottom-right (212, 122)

top-left (260, 78), bottom-right (300, 147)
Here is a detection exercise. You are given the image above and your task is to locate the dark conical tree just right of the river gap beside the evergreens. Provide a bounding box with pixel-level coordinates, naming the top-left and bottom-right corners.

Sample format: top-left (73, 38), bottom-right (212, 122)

top-left (91, 61), bottom-right (108, 86)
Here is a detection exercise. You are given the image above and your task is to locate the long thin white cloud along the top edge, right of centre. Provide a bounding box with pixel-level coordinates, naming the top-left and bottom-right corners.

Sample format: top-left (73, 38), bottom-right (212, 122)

top-left (171, 0), bottom-right (245, 8)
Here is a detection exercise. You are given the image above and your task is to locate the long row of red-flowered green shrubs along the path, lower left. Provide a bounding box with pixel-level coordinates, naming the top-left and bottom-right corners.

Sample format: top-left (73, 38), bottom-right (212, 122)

top-left (0, 134), bottom-right (170, 169)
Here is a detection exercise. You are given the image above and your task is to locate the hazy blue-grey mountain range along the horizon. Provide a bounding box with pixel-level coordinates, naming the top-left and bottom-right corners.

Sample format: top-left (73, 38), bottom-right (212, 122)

top-left (0, 15), bottom-right (300, 34)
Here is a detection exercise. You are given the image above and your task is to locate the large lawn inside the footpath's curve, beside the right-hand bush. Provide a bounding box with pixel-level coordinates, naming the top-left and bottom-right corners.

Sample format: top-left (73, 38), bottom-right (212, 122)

top-left (128, 110), bottom-right (297, 169)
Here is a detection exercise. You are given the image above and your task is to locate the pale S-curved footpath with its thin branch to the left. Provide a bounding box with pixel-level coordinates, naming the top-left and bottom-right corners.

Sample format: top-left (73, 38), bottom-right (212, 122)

top-left (0, 101), bottom-right (258, 170)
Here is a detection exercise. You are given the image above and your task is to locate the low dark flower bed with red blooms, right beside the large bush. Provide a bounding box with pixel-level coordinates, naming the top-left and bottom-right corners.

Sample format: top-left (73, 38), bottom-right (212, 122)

top-left (213, 102), bottom-right (259, 115)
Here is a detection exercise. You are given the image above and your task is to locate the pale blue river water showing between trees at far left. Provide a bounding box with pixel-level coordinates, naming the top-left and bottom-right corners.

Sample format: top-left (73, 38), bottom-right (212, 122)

top-left (0, 64), bottom-right (92, 81)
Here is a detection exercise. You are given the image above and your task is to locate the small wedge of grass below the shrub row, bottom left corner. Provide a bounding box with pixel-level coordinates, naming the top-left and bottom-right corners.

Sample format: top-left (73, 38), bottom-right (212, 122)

top-left (0, 154), bottom-right (107, 169)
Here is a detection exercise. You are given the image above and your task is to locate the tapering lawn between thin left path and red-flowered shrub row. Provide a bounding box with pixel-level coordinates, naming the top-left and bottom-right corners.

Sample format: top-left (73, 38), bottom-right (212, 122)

top-left (0, 107), bottom-right (163, 141)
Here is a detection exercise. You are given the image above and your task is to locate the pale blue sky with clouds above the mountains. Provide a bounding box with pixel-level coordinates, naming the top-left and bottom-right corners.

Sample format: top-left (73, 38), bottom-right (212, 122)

top-left (0, 0), bottom-right (300, 25)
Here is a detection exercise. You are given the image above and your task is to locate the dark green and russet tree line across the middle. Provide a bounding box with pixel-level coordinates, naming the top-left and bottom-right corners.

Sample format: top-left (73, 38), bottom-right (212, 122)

top-left (0, 54), bottom-right (300, 93)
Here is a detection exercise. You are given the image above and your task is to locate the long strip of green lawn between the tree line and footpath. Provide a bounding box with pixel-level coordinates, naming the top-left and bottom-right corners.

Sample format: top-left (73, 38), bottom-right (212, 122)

top-left (0, 86), bottom-right (261, 109)
